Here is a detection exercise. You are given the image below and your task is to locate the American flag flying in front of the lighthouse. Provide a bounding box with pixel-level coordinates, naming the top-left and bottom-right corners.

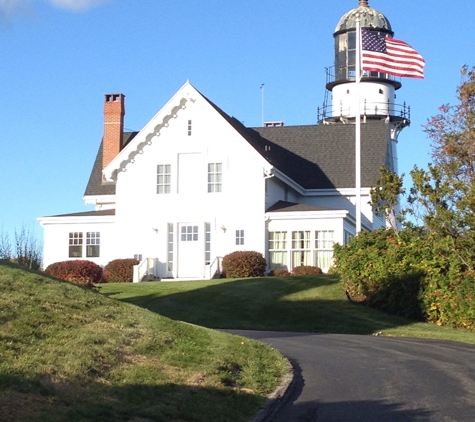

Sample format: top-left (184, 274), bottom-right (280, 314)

top-left (361, 29), bottom-right (425, 79)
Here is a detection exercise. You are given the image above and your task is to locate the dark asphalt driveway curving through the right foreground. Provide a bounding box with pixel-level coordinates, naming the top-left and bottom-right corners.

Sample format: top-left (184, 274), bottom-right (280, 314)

top-left (227, 330), bottom-right (475, 422)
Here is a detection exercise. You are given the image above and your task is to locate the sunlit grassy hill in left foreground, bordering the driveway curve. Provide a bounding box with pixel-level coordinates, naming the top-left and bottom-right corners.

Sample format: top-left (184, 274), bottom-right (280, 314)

top-left (0, 262), bottom-right (288, 422)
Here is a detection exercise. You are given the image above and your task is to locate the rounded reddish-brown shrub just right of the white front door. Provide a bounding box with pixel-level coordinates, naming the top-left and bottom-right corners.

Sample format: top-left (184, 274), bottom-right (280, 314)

top-left (223, 251), bottom-right (267, 278)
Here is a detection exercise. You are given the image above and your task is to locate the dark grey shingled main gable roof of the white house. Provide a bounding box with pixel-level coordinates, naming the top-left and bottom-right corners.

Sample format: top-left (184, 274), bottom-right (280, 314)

top-left (85, 83), bottom-right (389, 196)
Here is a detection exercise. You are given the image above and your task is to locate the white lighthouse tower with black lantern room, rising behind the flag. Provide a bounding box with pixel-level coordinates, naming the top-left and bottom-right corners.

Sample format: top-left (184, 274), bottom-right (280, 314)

top-left (318, 0), bottom-right (410, 173)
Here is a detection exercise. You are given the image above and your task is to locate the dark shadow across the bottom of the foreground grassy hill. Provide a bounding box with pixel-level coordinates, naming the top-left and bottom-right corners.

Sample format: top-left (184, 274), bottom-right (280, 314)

top-left (0, 374), bottom-right (265, 422)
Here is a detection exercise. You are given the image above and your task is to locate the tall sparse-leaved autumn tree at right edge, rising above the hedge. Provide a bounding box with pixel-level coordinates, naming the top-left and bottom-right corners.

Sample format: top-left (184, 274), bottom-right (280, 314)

top-left (408, 66), bottom-right (475, 270)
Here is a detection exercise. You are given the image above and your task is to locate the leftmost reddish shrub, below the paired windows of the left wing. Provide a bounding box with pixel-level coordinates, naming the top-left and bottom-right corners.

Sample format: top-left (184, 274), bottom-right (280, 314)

top-left (45, 259), bottom-right (102, 287)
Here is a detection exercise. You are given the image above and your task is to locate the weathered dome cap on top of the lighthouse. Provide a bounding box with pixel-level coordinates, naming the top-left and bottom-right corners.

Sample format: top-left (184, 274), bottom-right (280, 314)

top-left (334, 0), bottom-right (394, 35)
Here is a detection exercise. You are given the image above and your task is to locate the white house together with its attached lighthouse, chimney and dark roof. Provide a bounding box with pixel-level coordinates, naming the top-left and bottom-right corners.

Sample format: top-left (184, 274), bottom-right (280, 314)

top-left (39, 1), bottom-right (409, 279)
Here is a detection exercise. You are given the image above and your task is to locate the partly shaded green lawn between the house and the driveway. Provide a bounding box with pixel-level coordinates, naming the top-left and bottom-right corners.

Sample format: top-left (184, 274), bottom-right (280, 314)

top-left (100, 275), bottom-right (475, 344)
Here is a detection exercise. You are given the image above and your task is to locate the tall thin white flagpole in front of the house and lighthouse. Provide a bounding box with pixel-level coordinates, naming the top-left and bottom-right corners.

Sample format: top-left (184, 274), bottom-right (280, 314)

top-left (355, 16), bottom-right (362, 234)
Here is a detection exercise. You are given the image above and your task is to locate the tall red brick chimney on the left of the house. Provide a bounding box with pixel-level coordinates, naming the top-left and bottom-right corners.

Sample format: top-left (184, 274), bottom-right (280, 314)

top-left (102, 94), bottom-right (125, 169)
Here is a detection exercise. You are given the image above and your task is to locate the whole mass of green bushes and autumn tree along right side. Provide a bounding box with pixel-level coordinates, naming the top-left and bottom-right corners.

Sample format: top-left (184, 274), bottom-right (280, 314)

top-left (335, 66), bottom-right (475, 330)
